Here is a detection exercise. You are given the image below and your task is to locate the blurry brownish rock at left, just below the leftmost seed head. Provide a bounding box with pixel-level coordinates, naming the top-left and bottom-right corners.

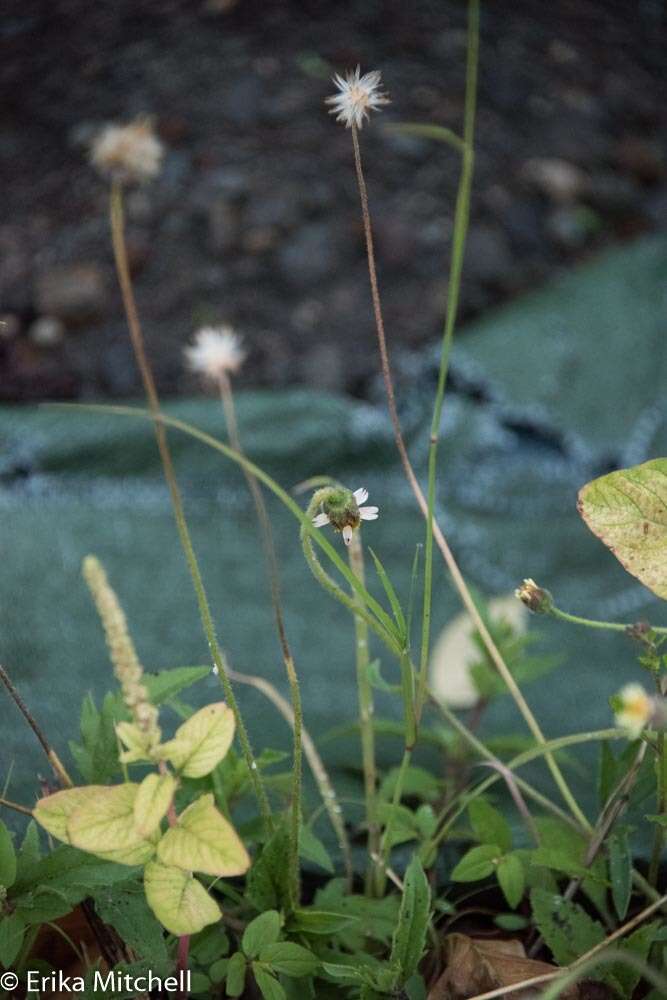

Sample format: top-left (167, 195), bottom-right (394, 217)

top-left (35, 264), bottom-right (106, 326)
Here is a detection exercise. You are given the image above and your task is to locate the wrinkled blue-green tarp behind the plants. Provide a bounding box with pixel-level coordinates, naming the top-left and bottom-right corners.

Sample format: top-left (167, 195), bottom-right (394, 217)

top-left (0, 239), bottom-right (667, 840)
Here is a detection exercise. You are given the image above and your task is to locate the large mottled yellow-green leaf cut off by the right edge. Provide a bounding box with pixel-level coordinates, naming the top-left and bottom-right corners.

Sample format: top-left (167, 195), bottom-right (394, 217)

top-left (578, 458), bottom-right (667, 599)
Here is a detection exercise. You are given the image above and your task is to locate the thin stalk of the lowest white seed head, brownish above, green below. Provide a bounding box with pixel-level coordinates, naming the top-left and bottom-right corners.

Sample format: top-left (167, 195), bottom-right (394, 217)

top-left (219, 372), bottom-right (303, 907)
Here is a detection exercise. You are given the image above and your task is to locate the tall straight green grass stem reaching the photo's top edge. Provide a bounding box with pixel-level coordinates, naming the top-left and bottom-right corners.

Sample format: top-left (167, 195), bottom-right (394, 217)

top-left (417, 0), bottom-right (479, 717)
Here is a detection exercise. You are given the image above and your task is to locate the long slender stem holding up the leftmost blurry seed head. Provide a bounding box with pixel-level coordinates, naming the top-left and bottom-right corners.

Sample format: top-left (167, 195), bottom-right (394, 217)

top-left (110, 183), bottom-right (273, 830)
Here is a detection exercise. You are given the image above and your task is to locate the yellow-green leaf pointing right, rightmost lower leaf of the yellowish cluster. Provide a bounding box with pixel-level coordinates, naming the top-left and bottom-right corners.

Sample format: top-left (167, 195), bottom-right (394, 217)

top-left (158, 795), bottom-right (250, 875)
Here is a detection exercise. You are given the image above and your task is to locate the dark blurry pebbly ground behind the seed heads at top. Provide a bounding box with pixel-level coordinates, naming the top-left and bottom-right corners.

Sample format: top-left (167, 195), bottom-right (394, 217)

top-left (0, 0), bottom-right (667, 401)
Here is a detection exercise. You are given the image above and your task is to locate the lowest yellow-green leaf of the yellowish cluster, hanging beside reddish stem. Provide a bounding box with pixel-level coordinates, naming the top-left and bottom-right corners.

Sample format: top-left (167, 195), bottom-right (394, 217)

top-left (144, 861), bottom-right (222, 937)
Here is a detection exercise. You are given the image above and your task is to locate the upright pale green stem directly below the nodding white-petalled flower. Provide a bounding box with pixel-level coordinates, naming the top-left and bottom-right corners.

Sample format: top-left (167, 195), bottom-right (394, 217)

top-left (348, 531), bottom-right (380, 896)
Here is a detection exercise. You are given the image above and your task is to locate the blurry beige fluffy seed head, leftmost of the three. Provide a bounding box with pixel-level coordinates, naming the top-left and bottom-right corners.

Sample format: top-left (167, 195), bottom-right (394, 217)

top-left (90, 118), bottom-right (164, 184)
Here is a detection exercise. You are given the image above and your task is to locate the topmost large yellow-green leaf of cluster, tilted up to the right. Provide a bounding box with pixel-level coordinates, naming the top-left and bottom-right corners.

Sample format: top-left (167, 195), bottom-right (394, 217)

top-left (160, 701), bottom-right (236, 778)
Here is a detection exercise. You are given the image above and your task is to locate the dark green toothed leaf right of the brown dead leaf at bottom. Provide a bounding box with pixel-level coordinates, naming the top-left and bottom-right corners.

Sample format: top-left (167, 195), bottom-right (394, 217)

top-left (530, 889), bottom-right (605, 965)
